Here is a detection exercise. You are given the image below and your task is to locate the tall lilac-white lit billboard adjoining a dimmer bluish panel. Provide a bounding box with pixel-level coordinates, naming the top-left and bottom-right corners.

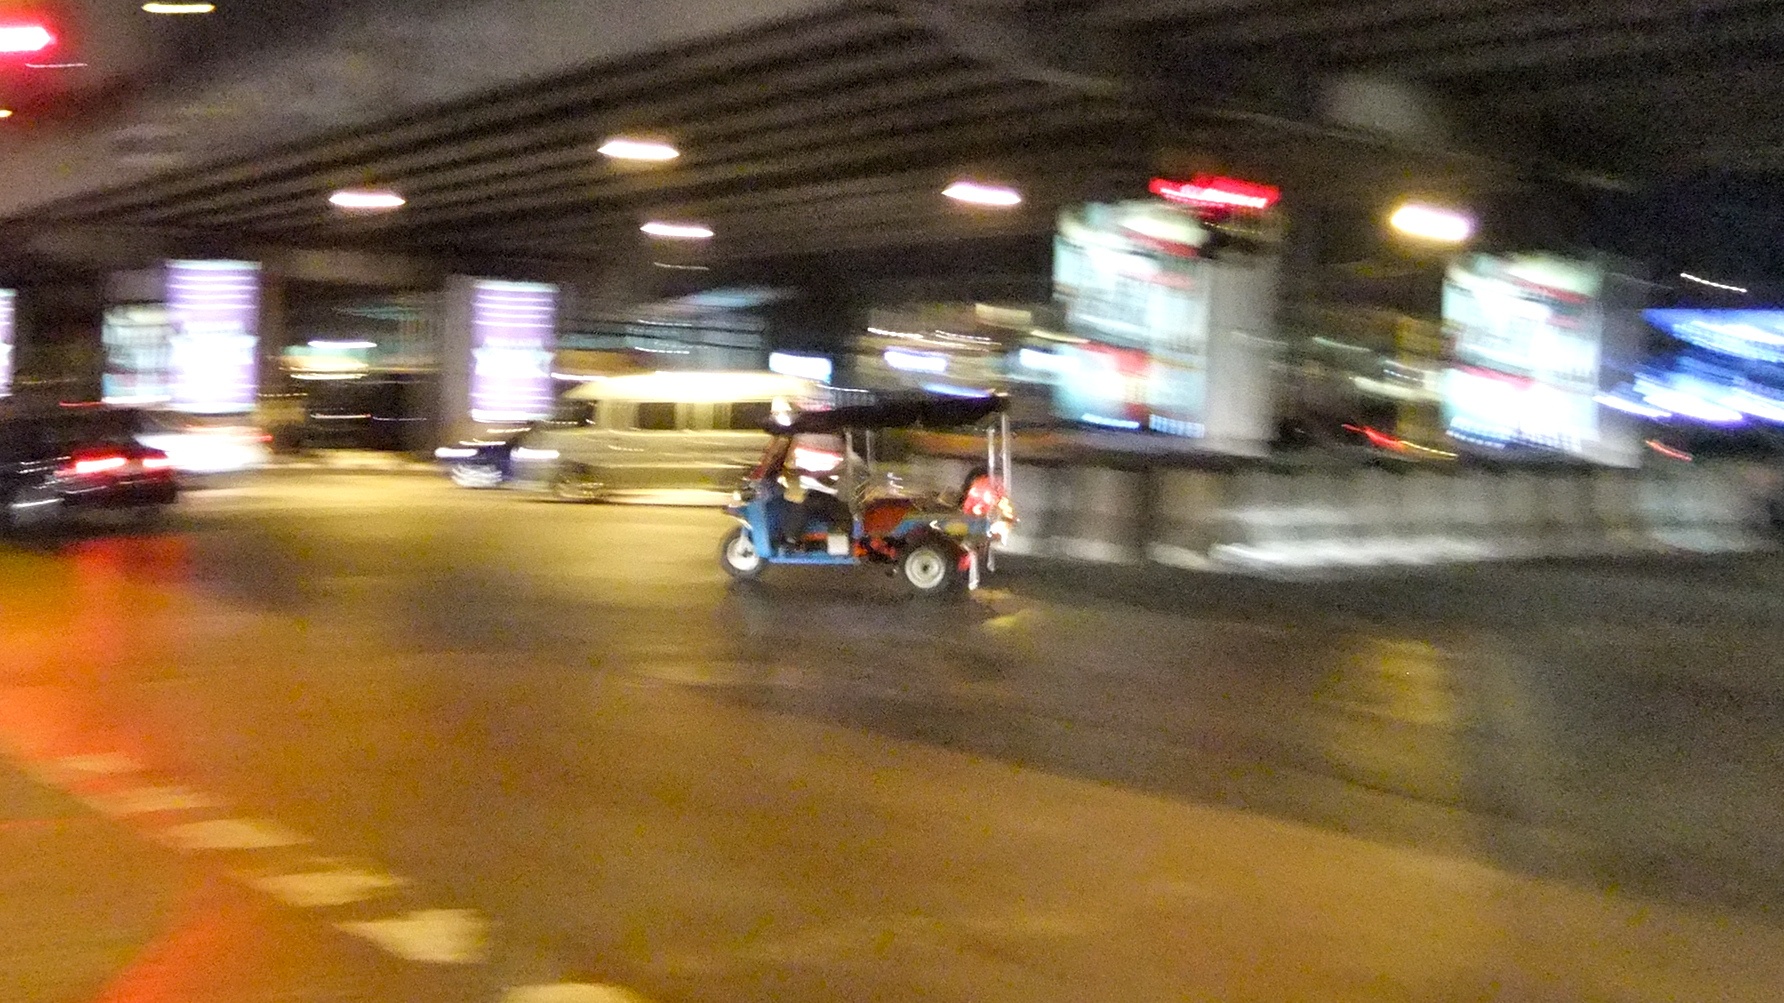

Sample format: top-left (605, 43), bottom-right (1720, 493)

top-left (166, 261), bottom-right (260, 414)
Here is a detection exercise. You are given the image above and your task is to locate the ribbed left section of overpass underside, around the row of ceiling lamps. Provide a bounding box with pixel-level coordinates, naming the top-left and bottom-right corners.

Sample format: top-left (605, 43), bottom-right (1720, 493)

top-left (10, 7), bottom-right (1149, 259)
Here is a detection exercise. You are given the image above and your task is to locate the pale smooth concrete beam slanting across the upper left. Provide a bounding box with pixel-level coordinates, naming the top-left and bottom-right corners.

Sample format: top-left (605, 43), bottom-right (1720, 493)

top-left (0, 0), bottom-right (842, 218)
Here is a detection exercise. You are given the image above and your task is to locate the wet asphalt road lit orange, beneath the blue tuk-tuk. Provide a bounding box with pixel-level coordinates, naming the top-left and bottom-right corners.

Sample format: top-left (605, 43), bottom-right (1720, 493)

top-left (0, 471), bottom-right (1784, 1003)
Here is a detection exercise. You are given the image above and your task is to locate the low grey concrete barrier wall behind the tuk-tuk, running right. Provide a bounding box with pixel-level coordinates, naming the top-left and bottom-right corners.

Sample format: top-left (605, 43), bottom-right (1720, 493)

top-left (949, 460), bottom-right (1775, 573)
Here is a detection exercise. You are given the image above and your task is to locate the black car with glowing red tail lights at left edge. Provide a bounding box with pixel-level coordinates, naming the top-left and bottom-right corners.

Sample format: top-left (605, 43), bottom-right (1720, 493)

top-left (0, 407), bottom-right (178, 532)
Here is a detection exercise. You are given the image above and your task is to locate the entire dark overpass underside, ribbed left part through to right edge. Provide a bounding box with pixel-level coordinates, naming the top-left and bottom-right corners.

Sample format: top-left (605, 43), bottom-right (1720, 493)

top-left (12, 0), bottom-right (1784, 273)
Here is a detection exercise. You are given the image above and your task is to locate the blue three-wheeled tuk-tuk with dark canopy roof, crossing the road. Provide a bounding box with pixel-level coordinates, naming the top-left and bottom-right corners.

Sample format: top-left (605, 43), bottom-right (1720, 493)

top-left (719, 394), bottom-right (1015, 594)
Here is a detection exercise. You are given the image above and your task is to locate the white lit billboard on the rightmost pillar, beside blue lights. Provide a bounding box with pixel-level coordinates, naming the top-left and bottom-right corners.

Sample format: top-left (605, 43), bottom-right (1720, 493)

top-left (1441, 253), bottom-right (1604, 455)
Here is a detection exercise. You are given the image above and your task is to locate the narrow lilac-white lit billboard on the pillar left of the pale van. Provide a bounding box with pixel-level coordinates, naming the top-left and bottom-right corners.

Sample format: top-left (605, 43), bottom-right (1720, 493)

top-left (471, 278), bottom-right (557, 421)
